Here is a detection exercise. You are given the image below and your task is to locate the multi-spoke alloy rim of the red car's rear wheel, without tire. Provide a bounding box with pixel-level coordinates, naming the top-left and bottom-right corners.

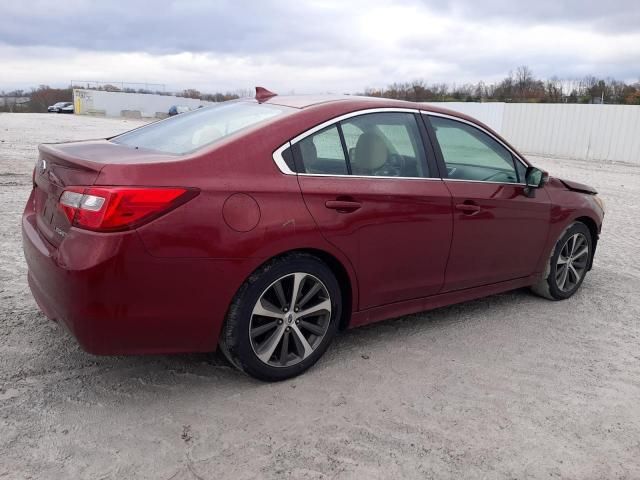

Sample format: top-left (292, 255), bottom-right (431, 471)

top-left (249, 272), bottom-right (331, 367)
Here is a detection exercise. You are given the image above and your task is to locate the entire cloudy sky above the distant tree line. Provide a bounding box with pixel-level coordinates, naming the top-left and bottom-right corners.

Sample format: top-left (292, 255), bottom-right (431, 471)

top-left (0, 0), bottom-right (640, 93)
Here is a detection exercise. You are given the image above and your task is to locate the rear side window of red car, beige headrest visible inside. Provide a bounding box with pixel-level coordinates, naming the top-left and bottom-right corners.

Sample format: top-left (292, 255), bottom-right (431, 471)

top-left (297, 112), bottom-right (429, 177)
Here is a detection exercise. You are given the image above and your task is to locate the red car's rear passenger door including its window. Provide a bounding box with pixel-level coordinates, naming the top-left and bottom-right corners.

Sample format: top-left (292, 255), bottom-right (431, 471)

top-left (292, 111), bottom-right (452, 310)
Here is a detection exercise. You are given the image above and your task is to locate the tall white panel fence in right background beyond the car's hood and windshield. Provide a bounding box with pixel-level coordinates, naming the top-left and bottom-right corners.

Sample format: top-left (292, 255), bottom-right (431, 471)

top-left (424, 103), bottom-right (640, 164)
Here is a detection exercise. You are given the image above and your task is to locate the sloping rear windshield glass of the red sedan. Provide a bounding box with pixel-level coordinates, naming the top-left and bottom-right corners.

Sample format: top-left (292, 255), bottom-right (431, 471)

top-left (111, 102), bottom-right (294, 155)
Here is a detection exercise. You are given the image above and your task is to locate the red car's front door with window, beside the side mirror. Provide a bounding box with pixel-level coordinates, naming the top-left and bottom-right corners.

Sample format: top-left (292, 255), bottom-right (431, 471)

top-left (427, 114), bottom-right (551, 291)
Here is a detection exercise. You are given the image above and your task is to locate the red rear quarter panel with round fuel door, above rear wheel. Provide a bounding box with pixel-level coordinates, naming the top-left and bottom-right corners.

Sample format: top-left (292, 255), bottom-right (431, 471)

top-left (96, 130), bottom-right (358, 324)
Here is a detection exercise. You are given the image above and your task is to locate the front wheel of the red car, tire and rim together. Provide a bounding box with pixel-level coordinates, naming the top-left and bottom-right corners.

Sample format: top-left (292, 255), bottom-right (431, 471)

top-left (532, 222), bottom-right (593, 300)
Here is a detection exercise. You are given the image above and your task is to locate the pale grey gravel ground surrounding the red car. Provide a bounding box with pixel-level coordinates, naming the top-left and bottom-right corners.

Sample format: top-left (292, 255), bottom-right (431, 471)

top-left (0, 114), bottom-right (640, 479)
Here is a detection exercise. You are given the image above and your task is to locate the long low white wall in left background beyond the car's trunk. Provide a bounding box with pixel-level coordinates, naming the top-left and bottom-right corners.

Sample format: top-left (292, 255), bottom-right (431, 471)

top-left (73, 89), bottom-right (211, 118)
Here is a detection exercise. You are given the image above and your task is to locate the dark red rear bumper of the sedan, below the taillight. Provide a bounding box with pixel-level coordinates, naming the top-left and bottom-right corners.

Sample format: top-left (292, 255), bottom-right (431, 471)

top-left (22, 195), bottom-right (249, 355)
